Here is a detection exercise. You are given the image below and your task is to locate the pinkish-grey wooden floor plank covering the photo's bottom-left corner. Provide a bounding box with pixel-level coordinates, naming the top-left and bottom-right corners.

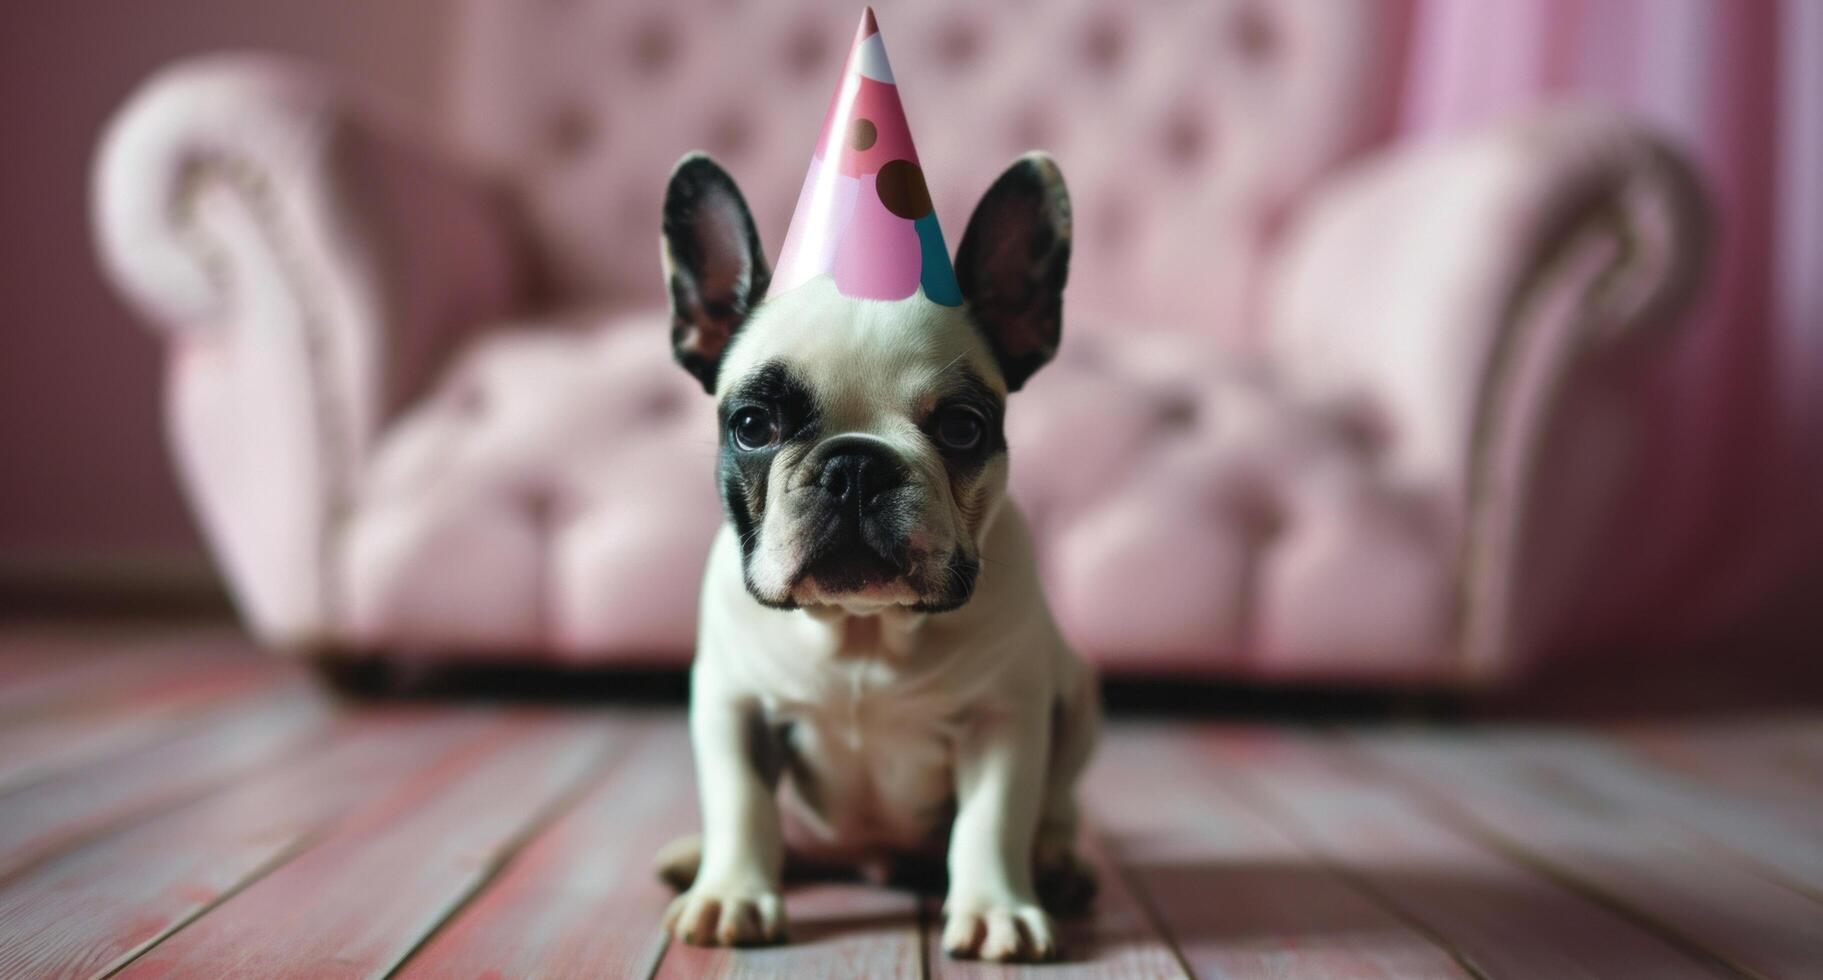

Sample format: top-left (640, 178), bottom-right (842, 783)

top-left (0, 710), bottom-right (501, 976)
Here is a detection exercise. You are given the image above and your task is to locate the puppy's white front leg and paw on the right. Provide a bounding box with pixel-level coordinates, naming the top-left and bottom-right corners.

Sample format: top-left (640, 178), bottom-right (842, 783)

top-left (942, 705), bottom-right (1057, 960)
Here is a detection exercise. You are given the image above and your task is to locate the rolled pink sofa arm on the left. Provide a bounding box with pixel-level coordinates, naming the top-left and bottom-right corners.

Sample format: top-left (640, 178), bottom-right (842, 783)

top-left (91, 55), bottom-right (521, 647)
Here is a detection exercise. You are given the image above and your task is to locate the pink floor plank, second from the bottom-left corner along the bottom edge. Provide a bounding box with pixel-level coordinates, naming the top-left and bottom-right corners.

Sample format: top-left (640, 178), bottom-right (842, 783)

top-left (122, 712), bottom-right (620, 978)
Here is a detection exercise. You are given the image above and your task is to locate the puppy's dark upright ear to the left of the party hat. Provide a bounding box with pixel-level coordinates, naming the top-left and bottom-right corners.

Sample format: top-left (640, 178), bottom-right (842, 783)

top-left (664, 153), bottom-right (773, 393)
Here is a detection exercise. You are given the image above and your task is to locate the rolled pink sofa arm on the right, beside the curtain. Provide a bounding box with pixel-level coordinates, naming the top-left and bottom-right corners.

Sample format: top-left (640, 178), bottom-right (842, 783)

top-left (1269, 107), bottom-right (1708, 679)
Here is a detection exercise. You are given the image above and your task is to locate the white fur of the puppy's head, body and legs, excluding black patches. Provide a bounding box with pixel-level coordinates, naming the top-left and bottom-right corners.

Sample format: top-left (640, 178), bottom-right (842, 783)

top-left (667, 281), bottom-right (1097, 958)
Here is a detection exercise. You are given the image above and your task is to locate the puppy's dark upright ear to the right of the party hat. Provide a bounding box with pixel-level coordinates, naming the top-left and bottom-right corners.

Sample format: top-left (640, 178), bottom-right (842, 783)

top-left (955, 153), bottom-right (1070, 392)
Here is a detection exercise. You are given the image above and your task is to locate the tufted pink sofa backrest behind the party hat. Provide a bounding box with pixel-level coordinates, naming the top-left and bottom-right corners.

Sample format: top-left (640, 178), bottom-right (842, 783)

top-left (456, 0), bottom-right (1407, 339)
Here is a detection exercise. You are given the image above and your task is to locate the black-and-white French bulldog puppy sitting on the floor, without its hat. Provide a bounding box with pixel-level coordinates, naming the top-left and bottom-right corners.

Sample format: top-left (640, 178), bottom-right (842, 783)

top-left (660, 155), bottom-right (1099, 960)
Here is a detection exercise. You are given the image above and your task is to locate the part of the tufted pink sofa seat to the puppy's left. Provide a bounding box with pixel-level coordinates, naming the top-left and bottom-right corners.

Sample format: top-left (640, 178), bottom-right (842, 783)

top-left (341, 313), bottom-right (718, 661)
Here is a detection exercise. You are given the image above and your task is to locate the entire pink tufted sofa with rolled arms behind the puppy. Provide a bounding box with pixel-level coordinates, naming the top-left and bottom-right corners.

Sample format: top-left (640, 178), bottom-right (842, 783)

top-left (95, 0), bottom-right (1706, 685)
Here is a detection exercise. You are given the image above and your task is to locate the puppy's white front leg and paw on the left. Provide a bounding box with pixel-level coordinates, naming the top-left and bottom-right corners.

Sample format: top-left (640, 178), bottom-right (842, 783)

top-left (665, 692), bottom-right (786, 945)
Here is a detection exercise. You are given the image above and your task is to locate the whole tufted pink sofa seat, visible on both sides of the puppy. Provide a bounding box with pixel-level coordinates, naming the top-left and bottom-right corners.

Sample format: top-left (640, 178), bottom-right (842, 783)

top-left (341, 311), bottom-right (1453, 678)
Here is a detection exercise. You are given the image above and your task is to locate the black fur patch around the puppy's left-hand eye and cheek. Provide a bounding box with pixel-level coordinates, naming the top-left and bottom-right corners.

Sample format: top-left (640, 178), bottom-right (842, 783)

top-left (716, 361), bottom-right (822, 608)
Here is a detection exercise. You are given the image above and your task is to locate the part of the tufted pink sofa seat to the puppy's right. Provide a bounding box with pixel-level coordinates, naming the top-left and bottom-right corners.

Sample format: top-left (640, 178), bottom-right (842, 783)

top-left (1008, 328), bottom-right (1455, 679)
